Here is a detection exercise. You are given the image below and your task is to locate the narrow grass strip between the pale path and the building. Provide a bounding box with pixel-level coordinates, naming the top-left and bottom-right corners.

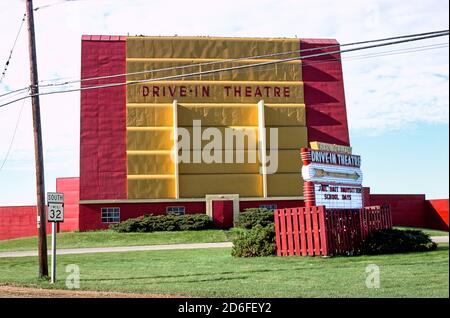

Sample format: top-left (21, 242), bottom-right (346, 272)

top-left (0, 229), bottom-right (238, 252)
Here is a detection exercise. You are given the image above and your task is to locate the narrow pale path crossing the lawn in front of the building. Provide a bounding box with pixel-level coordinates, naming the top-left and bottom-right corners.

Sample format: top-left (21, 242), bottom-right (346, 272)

top-left (0, 236), bottom-right (448, 258)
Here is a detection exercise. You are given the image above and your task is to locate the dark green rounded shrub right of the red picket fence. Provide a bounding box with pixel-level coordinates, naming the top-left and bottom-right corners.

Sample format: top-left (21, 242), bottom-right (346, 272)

top-left (360, 229), bottom-right (437, 255)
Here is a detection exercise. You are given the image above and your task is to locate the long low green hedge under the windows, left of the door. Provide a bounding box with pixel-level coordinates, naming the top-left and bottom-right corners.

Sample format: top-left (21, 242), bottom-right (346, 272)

top-left (109, 214), bottom-right (212, 233)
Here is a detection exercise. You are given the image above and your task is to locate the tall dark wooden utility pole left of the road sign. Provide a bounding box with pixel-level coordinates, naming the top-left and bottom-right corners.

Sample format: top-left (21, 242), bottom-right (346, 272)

top-left (26, 0), bottom-right (48, 278)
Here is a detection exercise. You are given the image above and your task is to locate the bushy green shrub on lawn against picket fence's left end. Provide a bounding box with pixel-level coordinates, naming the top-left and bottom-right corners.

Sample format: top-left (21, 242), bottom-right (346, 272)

top-left (231, 224), bottom-right (277, 257)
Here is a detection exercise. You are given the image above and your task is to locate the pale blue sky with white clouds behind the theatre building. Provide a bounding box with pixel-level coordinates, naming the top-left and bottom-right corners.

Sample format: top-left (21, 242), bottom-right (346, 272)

top-left (0, 0), bottom-right (449, 206)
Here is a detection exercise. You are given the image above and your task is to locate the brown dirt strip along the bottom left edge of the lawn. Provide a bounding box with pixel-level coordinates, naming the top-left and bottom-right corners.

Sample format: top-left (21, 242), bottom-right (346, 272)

top-left (0, 285), bottom-right (182, 298)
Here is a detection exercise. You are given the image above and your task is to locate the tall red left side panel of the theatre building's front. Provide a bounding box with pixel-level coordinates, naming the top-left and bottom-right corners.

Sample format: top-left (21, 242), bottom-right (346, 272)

top-left (80, 36), bottom-right (127, 200)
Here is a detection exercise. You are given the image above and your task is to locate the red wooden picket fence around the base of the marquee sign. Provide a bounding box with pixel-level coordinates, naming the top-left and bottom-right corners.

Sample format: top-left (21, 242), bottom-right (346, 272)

top-left (274, 206), bottom-right (392, 256)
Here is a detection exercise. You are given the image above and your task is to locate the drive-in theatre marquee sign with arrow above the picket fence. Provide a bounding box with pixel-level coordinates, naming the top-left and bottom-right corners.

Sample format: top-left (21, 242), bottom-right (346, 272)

top-left (301, 143), bottom-right (363, 209)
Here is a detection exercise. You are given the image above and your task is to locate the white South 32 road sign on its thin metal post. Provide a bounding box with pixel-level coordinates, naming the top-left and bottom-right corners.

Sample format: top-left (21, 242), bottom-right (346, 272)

top-left (47, 192), bottom-right (64, 284)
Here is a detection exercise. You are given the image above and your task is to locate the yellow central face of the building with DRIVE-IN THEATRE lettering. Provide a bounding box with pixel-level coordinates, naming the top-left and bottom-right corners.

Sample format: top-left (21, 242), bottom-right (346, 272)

top-left (126, 37), bottom-right (307, 199)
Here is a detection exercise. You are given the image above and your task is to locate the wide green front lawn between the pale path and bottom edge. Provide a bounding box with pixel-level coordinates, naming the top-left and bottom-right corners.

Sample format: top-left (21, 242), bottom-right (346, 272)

top-left (0, 244), bottom-right (449, 298)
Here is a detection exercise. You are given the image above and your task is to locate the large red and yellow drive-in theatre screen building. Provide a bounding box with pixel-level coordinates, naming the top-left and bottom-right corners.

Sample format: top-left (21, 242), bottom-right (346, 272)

top-left (79, 36), bottom-right (349, 228)
